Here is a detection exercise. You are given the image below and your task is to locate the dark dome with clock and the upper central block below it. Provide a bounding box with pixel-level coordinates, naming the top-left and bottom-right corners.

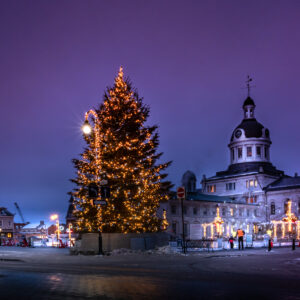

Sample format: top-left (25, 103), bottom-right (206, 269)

top-left (202, 97), bottom-right (284, 195)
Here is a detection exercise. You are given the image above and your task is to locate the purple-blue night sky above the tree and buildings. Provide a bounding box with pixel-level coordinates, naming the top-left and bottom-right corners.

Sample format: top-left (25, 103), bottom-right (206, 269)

top-left (0, 0), bottom-right (300, 222)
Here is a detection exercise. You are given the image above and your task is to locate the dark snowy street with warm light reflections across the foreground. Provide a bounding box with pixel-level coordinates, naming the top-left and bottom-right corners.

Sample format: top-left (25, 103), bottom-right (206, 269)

top-left (0, 247), bottom-right (300, 300)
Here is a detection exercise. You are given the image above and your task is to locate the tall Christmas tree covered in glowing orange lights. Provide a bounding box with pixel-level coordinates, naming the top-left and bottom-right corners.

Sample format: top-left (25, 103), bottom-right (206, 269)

top-left (72, 68), bottom-right (170, 233)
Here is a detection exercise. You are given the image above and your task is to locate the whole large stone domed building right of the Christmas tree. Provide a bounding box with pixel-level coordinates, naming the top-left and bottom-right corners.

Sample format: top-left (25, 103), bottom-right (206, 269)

top-left (161, 96), bottom-right (300, 243)
